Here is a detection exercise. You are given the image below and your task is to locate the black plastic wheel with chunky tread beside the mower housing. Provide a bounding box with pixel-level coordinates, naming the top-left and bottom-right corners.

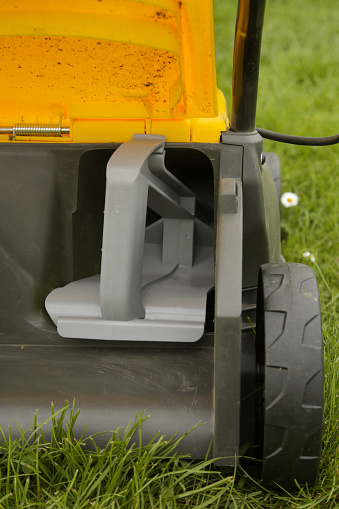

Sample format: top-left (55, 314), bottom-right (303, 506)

top-left (256, 263), bottom-right (323, 490)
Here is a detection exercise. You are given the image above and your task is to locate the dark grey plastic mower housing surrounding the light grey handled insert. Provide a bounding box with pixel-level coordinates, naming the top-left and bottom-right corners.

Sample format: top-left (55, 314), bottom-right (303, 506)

top-left (0, 133), bottom-right (280, 465)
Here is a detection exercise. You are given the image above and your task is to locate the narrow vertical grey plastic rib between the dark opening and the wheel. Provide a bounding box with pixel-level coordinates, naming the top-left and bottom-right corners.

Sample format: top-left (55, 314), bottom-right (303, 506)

top-left (213, 176), bottom-right (243, 465)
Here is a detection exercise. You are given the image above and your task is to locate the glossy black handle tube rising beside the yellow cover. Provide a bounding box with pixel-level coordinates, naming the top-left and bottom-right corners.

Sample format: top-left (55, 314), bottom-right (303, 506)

top-left (230, 0), bottom-right (266, 133)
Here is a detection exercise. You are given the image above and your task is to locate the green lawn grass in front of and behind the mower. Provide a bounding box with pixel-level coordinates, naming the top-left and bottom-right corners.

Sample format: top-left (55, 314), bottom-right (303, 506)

top-left (0, 0), bottom-right (339, 509)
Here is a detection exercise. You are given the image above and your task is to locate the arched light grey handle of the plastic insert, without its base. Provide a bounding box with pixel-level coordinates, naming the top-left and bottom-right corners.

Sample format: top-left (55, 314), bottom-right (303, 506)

top-left (100, 135), bottom-right (202, 321)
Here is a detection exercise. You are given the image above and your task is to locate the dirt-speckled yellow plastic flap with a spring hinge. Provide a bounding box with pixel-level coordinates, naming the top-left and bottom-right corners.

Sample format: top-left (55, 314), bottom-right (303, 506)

top-left (0, 0), bottom-right (226, 142)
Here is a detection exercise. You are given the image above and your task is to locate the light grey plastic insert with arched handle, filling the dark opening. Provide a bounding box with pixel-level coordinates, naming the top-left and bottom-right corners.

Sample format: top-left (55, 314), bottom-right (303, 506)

top-left (46, 135), bottom-right (214, 342)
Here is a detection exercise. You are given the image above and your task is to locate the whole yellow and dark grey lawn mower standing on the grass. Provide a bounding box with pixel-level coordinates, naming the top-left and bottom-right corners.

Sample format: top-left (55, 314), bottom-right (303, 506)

top-left (0, 0), bottom-right (323, 488)
